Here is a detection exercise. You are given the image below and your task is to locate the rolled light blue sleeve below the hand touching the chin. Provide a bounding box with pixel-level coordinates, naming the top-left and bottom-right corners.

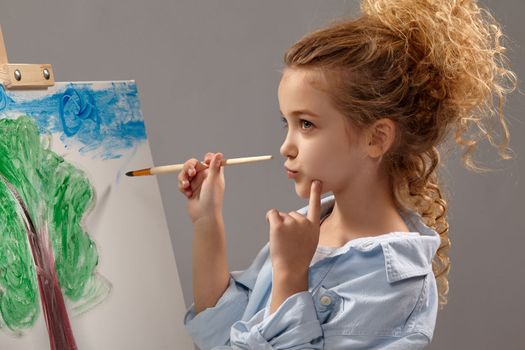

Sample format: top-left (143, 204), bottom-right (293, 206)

top-left (230, 291), bottom-right (324, 349)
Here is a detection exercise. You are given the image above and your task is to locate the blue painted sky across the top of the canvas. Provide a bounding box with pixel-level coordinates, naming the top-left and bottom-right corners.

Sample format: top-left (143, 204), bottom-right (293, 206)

top-left (0, 81), bottom-right (147, 159)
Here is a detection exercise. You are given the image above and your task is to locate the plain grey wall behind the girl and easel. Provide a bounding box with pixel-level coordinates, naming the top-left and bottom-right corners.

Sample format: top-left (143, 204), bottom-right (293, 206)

top-left (0, 0), bottom-right (525, 349)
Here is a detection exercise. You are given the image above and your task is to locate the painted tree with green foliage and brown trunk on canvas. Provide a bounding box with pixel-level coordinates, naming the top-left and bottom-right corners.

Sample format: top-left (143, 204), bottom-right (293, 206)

top-left (0, 116), bottom-right (111, 349)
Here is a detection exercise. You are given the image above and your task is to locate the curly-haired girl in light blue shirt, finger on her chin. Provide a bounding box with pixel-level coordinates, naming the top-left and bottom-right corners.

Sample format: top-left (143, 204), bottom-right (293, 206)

top-left (179, 0), bottom-right (516, 350)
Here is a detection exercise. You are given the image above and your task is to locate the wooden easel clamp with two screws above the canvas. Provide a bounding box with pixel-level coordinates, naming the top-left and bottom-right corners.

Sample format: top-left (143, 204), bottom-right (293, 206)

top-left (0, 27), bottom-right (55, 90)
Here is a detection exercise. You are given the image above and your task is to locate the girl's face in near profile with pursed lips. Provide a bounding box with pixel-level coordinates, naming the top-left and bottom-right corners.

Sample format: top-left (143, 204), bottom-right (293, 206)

top-left (278, 68), bottom-right (367, 198)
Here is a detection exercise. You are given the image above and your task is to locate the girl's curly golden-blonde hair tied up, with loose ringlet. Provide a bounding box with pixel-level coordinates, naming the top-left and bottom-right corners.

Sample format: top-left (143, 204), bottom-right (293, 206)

top-left (284, 0), bottom-right (517, 308)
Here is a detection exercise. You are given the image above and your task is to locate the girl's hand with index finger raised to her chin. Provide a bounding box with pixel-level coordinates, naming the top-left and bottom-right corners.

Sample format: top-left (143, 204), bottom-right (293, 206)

top-left (266, 180), bottom-right (322, 276)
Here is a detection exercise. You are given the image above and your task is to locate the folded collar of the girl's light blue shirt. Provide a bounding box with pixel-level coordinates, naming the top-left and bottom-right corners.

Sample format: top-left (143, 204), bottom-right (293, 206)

top-left (297, 194), bottom-right (441, 283)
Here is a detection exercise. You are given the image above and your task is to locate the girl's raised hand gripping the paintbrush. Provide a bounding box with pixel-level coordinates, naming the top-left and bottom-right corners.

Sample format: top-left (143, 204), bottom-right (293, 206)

top-left (178, 152), bottom-right (225, 223)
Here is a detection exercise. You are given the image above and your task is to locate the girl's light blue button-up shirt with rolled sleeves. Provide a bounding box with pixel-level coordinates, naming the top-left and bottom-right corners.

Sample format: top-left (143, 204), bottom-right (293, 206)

top-left (184, 195), bottom-right (440, 350)
